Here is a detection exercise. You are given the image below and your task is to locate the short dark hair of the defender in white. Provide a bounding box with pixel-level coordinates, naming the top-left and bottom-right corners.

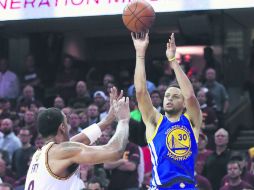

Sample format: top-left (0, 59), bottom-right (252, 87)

top-left (37, 108), bottom-right (64, 138)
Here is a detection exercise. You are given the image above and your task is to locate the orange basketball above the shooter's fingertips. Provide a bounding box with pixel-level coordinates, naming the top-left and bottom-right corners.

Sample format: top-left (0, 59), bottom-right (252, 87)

top-left (122, 0), bottom-right (155, 33)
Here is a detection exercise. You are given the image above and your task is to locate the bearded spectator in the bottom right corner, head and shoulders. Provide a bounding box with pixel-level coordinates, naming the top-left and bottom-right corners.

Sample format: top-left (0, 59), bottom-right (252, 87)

top-left (220, 161), bottom-right (253, 190)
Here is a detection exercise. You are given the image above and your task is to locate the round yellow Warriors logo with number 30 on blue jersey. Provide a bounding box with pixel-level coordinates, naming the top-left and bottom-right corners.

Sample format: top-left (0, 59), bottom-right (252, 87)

top-left (166, 125), bottom-right (192, 160)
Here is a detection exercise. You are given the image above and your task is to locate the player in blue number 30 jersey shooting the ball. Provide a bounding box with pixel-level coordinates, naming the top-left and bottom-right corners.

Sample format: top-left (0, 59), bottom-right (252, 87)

top-left (132, 33), bottom-right (202, 190)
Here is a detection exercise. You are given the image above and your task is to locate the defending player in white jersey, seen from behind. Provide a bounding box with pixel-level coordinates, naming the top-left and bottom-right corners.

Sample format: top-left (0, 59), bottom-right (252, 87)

top-left (25, 87), bottom-right (130, 190)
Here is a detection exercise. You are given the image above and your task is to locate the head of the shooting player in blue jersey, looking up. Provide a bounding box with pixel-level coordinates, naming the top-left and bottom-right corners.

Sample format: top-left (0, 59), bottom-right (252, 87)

top-left (163, 87), bottom-right (184, 114)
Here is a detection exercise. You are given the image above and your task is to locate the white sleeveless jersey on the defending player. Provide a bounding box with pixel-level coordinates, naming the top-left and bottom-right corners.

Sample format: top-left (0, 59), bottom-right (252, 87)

top-left (21, 142), bottom-right (84, 190)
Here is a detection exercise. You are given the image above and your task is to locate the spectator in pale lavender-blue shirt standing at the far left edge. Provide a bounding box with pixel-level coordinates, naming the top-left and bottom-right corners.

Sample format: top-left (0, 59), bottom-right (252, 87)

top-left (0, 58), bottom-right (19, 99)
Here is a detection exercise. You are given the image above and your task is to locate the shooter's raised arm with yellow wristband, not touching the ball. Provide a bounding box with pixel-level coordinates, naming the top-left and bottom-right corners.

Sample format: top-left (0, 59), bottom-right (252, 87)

top-left (166, 34), bottom-right (202, 139)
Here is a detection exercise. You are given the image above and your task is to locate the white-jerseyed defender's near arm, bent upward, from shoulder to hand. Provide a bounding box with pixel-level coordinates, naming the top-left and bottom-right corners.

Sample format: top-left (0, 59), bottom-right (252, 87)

top-left (57, 98), bottom-right (130, 166)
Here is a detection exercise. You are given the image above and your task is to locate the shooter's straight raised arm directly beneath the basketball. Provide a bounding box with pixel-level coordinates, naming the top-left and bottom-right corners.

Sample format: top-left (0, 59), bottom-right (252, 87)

top-left (131, 33), bottom-right (160, 139)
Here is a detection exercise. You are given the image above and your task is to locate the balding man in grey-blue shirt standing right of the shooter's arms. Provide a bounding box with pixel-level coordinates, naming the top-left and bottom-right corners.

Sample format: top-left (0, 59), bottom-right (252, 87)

top-left (205, 68), bottom-right (229, 127)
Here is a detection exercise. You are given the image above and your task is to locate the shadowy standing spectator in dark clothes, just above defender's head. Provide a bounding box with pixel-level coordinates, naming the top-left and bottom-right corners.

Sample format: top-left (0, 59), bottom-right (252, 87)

top-left (55, 55), bottom-right (79, 101)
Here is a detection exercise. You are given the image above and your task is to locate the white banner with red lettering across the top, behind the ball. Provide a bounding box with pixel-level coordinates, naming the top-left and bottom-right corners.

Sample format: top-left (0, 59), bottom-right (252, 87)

top-left (0, 0), bottom-right (254, 21)
